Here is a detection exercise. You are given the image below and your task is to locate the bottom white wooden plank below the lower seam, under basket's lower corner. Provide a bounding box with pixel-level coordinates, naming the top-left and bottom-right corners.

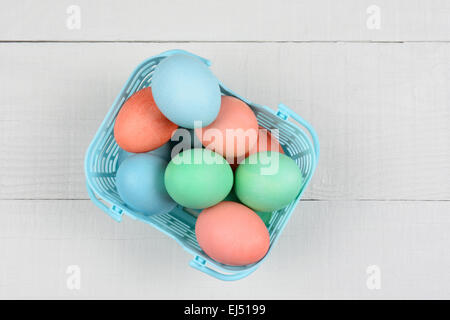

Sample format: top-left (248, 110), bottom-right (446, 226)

top-left (0, 200), bottom-right (450, 299)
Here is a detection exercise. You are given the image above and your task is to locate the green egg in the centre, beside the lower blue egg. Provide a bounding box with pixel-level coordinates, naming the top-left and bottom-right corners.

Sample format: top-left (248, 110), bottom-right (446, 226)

top-left (164, 148), bottom-right (233, 209)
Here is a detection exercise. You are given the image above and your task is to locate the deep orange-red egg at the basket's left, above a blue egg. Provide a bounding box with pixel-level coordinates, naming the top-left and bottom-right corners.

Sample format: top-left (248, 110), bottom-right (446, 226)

top-left (114, 88), bottom-right (178, 153)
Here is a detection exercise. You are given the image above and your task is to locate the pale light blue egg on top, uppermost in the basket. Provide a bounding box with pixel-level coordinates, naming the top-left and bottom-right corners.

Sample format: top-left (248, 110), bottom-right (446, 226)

top-left (151, 54), bottom-right (221, 129)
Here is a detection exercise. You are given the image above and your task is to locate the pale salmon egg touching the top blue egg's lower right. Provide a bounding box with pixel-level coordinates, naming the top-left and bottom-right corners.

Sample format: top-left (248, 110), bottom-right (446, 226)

top-left (195, 96), bottom-right (258, 159)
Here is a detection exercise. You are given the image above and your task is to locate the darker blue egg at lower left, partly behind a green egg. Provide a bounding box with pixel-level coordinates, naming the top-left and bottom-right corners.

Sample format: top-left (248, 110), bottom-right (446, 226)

top-left (116, 153), bottom-right (176, 215)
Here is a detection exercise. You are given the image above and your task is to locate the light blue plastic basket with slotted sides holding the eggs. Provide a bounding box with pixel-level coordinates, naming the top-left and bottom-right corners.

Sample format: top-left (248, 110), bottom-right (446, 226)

top-left (85, 50), bottom-right (319, 280)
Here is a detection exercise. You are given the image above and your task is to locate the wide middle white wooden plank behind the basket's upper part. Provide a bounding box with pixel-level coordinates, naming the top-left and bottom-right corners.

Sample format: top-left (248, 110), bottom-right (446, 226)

top-left (0, 43), bottom-right (450, 200)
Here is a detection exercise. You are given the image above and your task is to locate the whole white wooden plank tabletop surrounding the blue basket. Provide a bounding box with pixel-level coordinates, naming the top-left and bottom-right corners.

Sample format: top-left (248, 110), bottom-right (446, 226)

top-left (0, 0), bottom-right (450, 299)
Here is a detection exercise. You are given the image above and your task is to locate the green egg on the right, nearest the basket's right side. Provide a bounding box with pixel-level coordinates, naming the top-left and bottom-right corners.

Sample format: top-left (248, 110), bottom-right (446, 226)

top-left (234, 151), bottom-right (304, 212)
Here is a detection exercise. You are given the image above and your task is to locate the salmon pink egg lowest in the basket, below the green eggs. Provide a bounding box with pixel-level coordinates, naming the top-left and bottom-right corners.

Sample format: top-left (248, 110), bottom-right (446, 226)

top-left (195, 201), bottom-right (270, 266)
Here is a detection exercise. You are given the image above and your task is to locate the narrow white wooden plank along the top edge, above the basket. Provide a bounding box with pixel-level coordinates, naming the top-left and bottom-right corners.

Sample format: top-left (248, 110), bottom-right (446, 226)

top-left (0, 0), bottom-right (450, 41)
